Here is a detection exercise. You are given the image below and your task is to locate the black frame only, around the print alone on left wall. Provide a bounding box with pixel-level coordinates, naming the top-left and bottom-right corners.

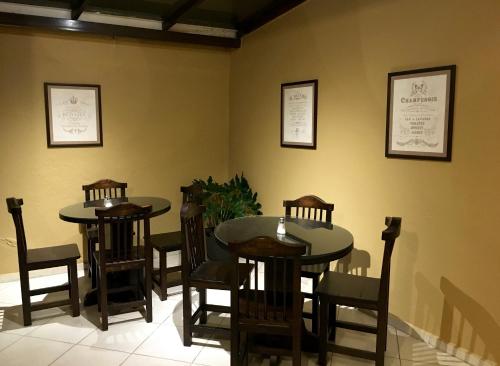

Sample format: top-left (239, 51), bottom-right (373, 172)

top-left (44, 82), bottom-right (103, 148)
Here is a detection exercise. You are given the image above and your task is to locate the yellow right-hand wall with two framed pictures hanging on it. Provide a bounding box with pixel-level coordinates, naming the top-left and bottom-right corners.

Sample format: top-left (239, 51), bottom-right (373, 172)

top-left (229, 0), bottom-right (500, 363)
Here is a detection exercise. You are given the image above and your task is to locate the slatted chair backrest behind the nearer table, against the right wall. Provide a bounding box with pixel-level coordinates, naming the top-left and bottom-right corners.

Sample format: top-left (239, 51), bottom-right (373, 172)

top-left (283, 195), bottom-right (333, 224)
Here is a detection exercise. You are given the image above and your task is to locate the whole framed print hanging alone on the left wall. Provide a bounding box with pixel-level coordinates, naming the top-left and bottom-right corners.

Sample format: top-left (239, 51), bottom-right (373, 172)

top-left (44, 83), bottom-right (102, 147)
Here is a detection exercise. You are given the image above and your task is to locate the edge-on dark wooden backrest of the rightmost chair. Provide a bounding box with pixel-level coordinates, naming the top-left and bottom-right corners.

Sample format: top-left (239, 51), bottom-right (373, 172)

top-left (379, 217), bottom-right (401, 301)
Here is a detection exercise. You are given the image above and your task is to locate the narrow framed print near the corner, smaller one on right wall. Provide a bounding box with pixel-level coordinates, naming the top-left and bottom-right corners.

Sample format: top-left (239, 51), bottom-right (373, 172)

top-left (281, 80), bottom-right (318, 149)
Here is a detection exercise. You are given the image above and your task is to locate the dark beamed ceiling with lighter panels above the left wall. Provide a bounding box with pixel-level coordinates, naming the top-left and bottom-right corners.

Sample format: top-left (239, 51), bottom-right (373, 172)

top-left (0, 0), bottom-right (306, 48)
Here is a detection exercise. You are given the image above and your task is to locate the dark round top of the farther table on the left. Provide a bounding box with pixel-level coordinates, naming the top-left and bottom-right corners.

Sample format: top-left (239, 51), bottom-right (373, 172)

top-left (59, 197), bottom-right (170, 224)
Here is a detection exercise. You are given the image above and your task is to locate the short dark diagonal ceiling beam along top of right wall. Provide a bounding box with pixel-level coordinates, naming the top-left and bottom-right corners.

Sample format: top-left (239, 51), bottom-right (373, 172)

top-left (236, 0), bottom-right (306, 37)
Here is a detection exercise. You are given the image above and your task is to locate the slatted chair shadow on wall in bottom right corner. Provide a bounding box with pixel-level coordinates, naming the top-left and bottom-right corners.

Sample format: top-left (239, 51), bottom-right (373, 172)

top-left (440, 277), bottom-right (500, 364)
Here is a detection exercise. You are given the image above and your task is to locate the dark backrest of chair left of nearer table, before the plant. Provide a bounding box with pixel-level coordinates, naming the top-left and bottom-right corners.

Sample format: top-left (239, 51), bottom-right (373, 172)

top-left (180, 202), bottom-right (206, 276)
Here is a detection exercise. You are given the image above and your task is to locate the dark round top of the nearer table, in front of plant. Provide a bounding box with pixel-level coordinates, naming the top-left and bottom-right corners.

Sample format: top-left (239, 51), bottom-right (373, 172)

top-left (215, 216), bottom-right (354, 264)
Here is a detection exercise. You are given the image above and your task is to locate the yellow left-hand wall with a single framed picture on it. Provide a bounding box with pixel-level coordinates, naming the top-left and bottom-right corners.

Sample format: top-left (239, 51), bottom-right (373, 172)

top-left (0, 29), bottom-right (230, 273)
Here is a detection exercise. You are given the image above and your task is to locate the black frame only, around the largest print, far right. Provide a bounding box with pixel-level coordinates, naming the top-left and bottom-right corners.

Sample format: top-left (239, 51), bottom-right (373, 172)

top-left (385, 65), bottom-right (456, 161)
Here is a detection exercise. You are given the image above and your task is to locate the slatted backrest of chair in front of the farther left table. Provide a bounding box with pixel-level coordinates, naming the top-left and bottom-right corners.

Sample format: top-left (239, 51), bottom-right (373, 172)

top-left (95, 203), bottom-right (152, 266)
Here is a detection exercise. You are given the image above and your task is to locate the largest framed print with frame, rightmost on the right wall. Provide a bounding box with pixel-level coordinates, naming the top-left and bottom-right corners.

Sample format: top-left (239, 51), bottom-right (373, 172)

top-left (385, 65), bottom-right (456, 161)
